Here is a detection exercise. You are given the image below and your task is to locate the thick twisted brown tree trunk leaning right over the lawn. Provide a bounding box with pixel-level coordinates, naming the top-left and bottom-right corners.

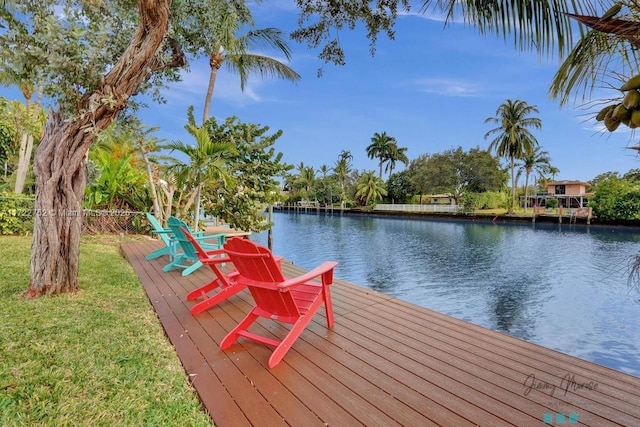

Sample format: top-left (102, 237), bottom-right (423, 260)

top-left (25, 0), bottom-right (174, 298)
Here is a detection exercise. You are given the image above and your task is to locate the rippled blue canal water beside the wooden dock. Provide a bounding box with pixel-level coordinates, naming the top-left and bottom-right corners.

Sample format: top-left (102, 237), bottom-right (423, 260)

top-left (252, 212), bottom-right (640, 376)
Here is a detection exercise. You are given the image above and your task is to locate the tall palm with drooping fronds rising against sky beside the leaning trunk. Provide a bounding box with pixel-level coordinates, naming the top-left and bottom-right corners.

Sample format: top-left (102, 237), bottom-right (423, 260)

top-left (202, 5), bottom-right (300, 123)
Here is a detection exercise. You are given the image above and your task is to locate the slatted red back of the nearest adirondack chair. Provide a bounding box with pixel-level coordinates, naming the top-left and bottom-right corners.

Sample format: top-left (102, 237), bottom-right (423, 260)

top-left (224, 237), bottom-right (300, 317)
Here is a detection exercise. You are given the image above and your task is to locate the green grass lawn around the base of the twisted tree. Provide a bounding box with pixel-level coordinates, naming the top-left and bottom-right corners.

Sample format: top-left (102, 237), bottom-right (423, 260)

top-left (0, 237), bottom-right (212, 426)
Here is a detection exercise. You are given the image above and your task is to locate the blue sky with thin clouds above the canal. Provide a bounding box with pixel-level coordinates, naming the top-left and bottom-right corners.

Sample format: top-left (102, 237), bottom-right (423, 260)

top-left (5, 0), bottom-right (640, 184)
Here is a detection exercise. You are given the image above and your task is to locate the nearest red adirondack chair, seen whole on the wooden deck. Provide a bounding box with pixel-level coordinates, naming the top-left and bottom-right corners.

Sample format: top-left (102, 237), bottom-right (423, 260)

top-left (220, 238), bottom-right (338, 368)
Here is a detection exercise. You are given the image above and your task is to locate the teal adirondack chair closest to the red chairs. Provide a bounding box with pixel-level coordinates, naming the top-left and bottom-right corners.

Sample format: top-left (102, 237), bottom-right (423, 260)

top-left (162, 216), bottom-right (225, 276)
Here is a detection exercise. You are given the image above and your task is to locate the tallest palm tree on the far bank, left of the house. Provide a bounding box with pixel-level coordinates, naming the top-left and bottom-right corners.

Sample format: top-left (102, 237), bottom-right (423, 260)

top-left (484, 99), bottom-right (542, 213)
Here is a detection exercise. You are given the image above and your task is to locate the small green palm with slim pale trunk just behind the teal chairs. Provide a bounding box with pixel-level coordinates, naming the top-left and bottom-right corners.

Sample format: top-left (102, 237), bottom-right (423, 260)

top-left (163, 108), bottom-right (235, 230)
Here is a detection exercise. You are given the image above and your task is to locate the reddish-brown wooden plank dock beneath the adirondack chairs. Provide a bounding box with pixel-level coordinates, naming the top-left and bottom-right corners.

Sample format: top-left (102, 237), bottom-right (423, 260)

top-left (122, 241), bottom-right (640, 427)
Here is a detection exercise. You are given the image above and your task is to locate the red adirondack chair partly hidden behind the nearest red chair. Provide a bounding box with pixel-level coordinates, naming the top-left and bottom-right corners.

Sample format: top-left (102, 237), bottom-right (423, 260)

top-left (180, 227), bottom-right (245, 314)
